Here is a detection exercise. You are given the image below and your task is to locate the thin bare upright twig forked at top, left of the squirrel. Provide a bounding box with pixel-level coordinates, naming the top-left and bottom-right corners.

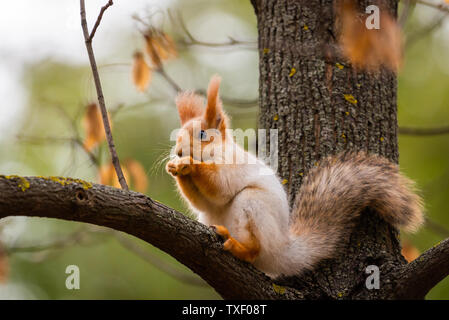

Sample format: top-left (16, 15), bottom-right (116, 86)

top-left (80, 0), bottom-right (128, 190)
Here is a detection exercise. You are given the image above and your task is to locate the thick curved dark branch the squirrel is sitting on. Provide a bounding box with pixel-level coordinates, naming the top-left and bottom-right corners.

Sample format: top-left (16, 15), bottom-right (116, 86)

top-left (0, 176), bottom-right (304, 299)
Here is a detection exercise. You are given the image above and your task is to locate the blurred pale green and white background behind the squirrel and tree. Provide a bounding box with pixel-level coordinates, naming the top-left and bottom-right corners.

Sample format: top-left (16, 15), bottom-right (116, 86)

top-left (0, 0), bottom-right (449, 299)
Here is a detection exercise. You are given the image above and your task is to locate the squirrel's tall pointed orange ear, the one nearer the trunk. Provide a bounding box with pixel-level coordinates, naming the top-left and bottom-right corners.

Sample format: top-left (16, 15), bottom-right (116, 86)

top-left (204, 75), bottom-right (227, 129)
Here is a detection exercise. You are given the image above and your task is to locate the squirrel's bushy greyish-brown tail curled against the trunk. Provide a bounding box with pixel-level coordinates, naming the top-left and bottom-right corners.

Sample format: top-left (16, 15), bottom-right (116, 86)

top-left (283, 152), bottom-right (424, 274)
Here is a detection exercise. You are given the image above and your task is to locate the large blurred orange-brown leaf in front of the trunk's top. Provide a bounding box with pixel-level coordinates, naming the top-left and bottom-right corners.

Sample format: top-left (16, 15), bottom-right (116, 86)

top-left (339, 1), bottom-right (402, 71)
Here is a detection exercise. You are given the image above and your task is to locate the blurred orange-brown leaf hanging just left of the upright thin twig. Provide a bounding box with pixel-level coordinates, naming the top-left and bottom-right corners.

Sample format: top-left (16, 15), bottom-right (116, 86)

top-left (83, 103), bottom-right (112, 151)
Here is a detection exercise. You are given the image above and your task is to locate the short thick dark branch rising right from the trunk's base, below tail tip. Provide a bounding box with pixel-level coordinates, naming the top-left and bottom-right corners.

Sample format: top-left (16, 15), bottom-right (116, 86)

top-left (392, 239), bottom-right (449, 299)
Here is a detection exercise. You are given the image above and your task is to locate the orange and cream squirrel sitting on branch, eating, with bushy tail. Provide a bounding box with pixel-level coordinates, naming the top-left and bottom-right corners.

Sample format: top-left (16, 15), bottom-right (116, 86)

top-left (166, 76), bottom-right (424, 277)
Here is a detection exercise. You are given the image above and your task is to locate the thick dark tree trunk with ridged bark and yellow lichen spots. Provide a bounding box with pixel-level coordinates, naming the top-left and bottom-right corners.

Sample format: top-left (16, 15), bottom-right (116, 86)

top-left (253, 0), bottom-right (405, 299)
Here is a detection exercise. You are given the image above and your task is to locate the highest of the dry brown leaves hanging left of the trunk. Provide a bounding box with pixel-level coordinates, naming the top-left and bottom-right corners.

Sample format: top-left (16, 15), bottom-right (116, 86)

top-left (144, 28), bottom-right (177, 67)
